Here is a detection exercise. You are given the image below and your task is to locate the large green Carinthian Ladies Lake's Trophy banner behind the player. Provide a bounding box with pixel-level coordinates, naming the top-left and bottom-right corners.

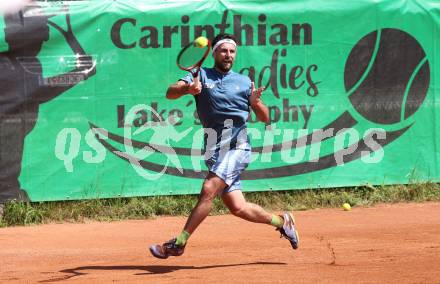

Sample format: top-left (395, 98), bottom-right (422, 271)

top-left (0, 0), bottom-right (440, 201)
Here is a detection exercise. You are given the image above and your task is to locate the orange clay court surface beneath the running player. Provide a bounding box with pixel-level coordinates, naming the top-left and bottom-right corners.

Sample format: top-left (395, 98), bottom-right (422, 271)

top-left (0, 202), bottom-right (440, 284)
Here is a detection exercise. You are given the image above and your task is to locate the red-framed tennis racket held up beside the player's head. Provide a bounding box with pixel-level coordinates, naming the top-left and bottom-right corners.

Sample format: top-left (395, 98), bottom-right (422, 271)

top-left (177, 37), bottom-right (211, 91)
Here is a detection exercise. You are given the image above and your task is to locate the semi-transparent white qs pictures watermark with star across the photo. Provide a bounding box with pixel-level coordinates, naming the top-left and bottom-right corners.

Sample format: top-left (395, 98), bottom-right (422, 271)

top-left (55, 104), bottom-right (387, 180)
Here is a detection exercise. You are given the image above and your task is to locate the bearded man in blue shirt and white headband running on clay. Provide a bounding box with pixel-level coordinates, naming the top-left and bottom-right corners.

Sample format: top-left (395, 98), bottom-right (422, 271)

top-left (150, 34), bottom-right (299, 259)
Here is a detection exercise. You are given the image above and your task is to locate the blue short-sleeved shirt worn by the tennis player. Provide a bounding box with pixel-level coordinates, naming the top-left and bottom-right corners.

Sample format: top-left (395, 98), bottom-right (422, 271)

top-left (181, 68), bottom-right (251, 154)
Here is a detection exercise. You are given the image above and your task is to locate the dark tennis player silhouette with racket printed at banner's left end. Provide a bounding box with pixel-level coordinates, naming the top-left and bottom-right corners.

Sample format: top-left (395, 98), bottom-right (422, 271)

top-left (0, 2), bottom-right (95, 203)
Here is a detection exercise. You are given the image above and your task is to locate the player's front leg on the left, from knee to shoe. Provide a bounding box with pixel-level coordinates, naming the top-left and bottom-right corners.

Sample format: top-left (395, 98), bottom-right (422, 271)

top-left (150, 172), bottom-right (227, 259)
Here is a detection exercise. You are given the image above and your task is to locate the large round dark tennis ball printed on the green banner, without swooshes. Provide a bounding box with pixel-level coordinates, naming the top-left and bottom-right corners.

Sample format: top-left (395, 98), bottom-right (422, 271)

top-left (344, 29), bottom-right (430, 124)
